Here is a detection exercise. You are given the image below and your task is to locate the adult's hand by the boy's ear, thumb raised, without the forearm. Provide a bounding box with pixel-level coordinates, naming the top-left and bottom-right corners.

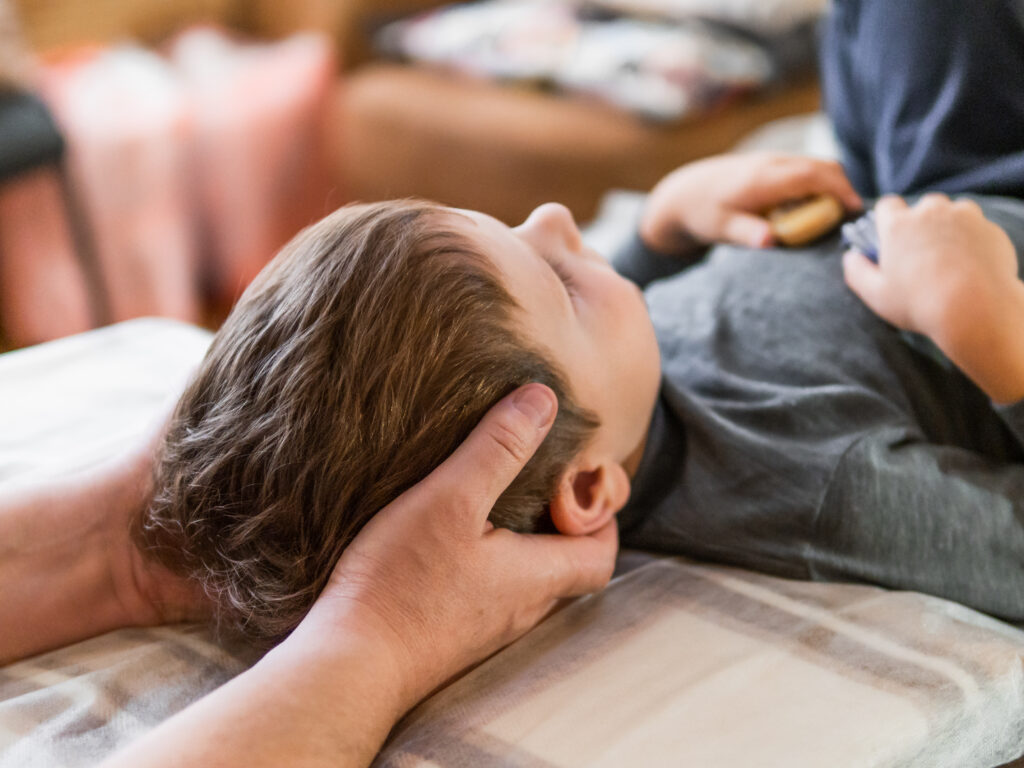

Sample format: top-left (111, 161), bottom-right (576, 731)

top-left (293, 384), bottom-right (618, 709)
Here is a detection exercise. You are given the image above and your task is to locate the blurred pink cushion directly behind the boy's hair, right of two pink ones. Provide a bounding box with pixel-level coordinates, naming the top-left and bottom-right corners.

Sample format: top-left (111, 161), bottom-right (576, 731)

top-left (170, 29), bottom-right (335, 302)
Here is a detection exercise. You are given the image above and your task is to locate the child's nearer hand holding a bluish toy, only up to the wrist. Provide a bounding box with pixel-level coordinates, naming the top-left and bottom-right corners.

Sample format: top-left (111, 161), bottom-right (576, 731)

top-left (843, 194), bottom-right (1019, 346)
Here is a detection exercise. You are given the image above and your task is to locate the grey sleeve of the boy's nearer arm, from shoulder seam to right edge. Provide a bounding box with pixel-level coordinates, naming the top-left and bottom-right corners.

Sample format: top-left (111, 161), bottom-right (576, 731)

top-left (807, 427), bottom-right (1024, 622)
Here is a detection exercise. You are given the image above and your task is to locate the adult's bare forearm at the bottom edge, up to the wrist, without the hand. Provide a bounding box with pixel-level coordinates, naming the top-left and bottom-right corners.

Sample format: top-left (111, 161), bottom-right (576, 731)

top-left (102, 614), bottom-right (412, 768)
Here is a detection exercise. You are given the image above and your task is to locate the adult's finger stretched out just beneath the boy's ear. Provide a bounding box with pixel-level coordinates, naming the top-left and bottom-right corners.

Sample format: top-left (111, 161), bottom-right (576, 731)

top-left (489, 518), bottom-right (618, 600)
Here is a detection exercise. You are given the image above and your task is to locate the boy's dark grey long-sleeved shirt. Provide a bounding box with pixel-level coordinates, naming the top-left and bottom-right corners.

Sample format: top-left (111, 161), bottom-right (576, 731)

top-left (614, 198), bottom-right (1024, 622)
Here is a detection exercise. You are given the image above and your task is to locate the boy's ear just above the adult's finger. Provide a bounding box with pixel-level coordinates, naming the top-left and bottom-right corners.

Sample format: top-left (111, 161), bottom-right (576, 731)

top-left (550, 462), bottom-right (630, 536)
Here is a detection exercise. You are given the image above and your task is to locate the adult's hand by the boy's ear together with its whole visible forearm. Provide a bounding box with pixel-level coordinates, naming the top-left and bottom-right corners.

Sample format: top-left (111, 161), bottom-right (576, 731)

top-left (99, 384), bottom-right (618, 767)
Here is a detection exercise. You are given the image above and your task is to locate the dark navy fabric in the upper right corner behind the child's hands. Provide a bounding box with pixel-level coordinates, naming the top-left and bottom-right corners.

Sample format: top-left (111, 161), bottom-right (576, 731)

top-left (820, 0), bottom-right (1024, 198)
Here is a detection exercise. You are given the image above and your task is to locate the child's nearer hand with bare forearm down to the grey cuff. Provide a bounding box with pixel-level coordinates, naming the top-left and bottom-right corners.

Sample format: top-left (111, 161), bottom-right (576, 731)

top-left (843, 195), bottom-right (1024, 403)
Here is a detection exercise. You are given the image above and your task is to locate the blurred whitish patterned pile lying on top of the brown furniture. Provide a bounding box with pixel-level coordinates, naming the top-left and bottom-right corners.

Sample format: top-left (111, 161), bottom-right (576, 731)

top-left (377, 0), bottom-right (806, 122)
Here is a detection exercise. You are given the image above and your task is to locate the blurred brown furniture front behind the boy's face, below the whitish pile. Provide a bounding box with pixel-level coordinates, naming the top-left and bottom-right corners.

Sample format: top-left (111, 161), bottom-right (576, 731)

top-left (330, 65), bottom-right (819, 223)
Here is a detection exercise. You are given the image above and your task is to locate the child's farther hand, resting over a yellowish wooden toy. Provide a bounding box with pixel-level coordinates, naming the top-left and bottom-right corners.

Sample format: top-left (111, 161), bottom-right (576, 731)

top-left (640, 153), bottom-right (863, 253)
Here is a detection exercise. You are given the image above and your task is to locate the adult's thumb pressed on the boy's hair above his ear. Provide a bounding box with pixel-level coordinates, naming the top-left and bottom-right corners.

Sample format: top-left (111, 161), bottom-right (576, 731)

top-left (417, 383), bottom-right (558, 530)
